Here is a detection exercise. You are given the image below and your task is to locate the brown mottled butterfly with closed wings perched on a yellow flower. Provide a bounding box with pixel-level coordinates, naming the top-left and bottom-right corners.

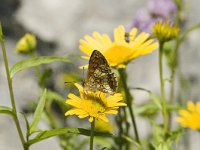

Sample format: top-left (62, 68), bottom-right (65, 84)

top-left (83, 50), bottom-right (117, 95)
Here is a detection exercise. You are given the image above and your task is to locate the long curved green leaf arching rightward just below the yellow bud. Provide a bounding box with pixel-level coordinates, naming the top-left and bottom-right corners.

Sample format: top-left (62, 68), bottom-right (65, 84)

top-left (10, 56), bottom-right (70, 78)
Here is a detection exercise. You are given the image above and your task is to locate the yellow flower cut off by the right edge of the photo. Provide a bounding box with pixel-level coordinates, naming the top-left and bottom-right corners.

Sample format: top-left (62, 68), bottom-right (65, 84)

top-left (176, 101), bottom-right (200, 130)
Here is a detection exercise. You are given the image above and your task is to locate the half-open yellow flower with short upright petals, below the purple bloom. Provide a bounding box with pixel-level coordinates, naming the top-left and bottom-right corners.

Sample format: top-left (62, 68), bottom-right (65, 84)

top-left (152, 21), bottom-right (179, 42)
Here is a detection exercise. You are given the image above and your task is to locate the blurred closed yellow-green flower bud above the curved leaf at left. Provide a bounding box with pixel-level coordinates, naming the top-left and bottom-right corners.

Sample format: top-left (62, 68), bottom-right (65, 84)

top-left (15, 33), bottom-right (37, 53)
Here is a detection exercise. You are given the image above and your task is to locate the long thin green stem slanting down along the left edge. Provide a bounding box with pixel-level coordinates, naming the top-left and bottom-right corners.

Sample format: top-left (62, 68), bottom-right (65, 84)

top-left (0, 24), bottom-right (28, 150)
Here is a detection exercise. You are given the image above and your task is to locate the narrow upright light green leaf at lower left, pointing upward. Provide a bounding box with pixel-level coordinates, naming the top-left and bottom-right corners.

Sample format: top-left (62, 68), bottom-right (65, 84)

top-left (30, 89), bottom-right (47, 133)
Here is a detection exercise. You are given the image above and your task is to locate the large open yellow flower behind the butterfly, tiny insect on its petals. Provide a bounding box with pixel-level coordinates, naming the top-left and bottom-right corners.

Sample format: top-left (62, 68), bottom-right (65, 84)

top-left (80, 25), bottom-right (158, 68)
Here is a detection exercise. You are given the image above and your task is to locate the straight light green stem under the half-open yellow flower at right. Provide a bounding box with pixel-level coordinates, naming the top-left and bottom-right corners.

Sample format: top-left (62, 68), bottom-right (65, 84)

top-left (158, 42), bottom-right (168, 131)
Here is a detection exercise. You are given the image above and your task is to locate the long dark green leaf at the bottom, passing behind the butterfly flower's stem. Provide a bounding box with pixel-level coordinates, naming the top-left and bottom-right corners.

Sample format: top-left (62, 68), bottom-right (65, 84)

top-left (27, 128), bottom-right (112, 145)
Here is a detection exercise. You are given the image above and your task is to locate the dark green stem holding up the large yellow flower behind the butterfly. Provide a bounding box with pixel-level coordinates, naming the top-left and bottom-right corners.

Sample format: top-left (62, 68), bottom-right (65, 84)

top-left (118, 69), bottom-right (140, 144)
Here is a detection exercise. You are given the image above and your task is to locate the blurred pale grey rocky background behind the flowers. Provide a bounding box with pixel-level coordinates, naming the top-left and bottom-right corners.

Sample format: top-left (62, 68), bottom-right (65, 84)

top-left (0, 0), bottom-right (200, 150)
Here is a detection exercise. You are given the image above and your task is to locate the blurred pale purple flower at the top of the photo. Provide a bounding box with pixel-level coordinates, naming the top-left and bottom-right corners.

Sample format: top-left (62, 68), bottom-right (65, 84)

top-left (129, 0), bottom-right (176, 33)
